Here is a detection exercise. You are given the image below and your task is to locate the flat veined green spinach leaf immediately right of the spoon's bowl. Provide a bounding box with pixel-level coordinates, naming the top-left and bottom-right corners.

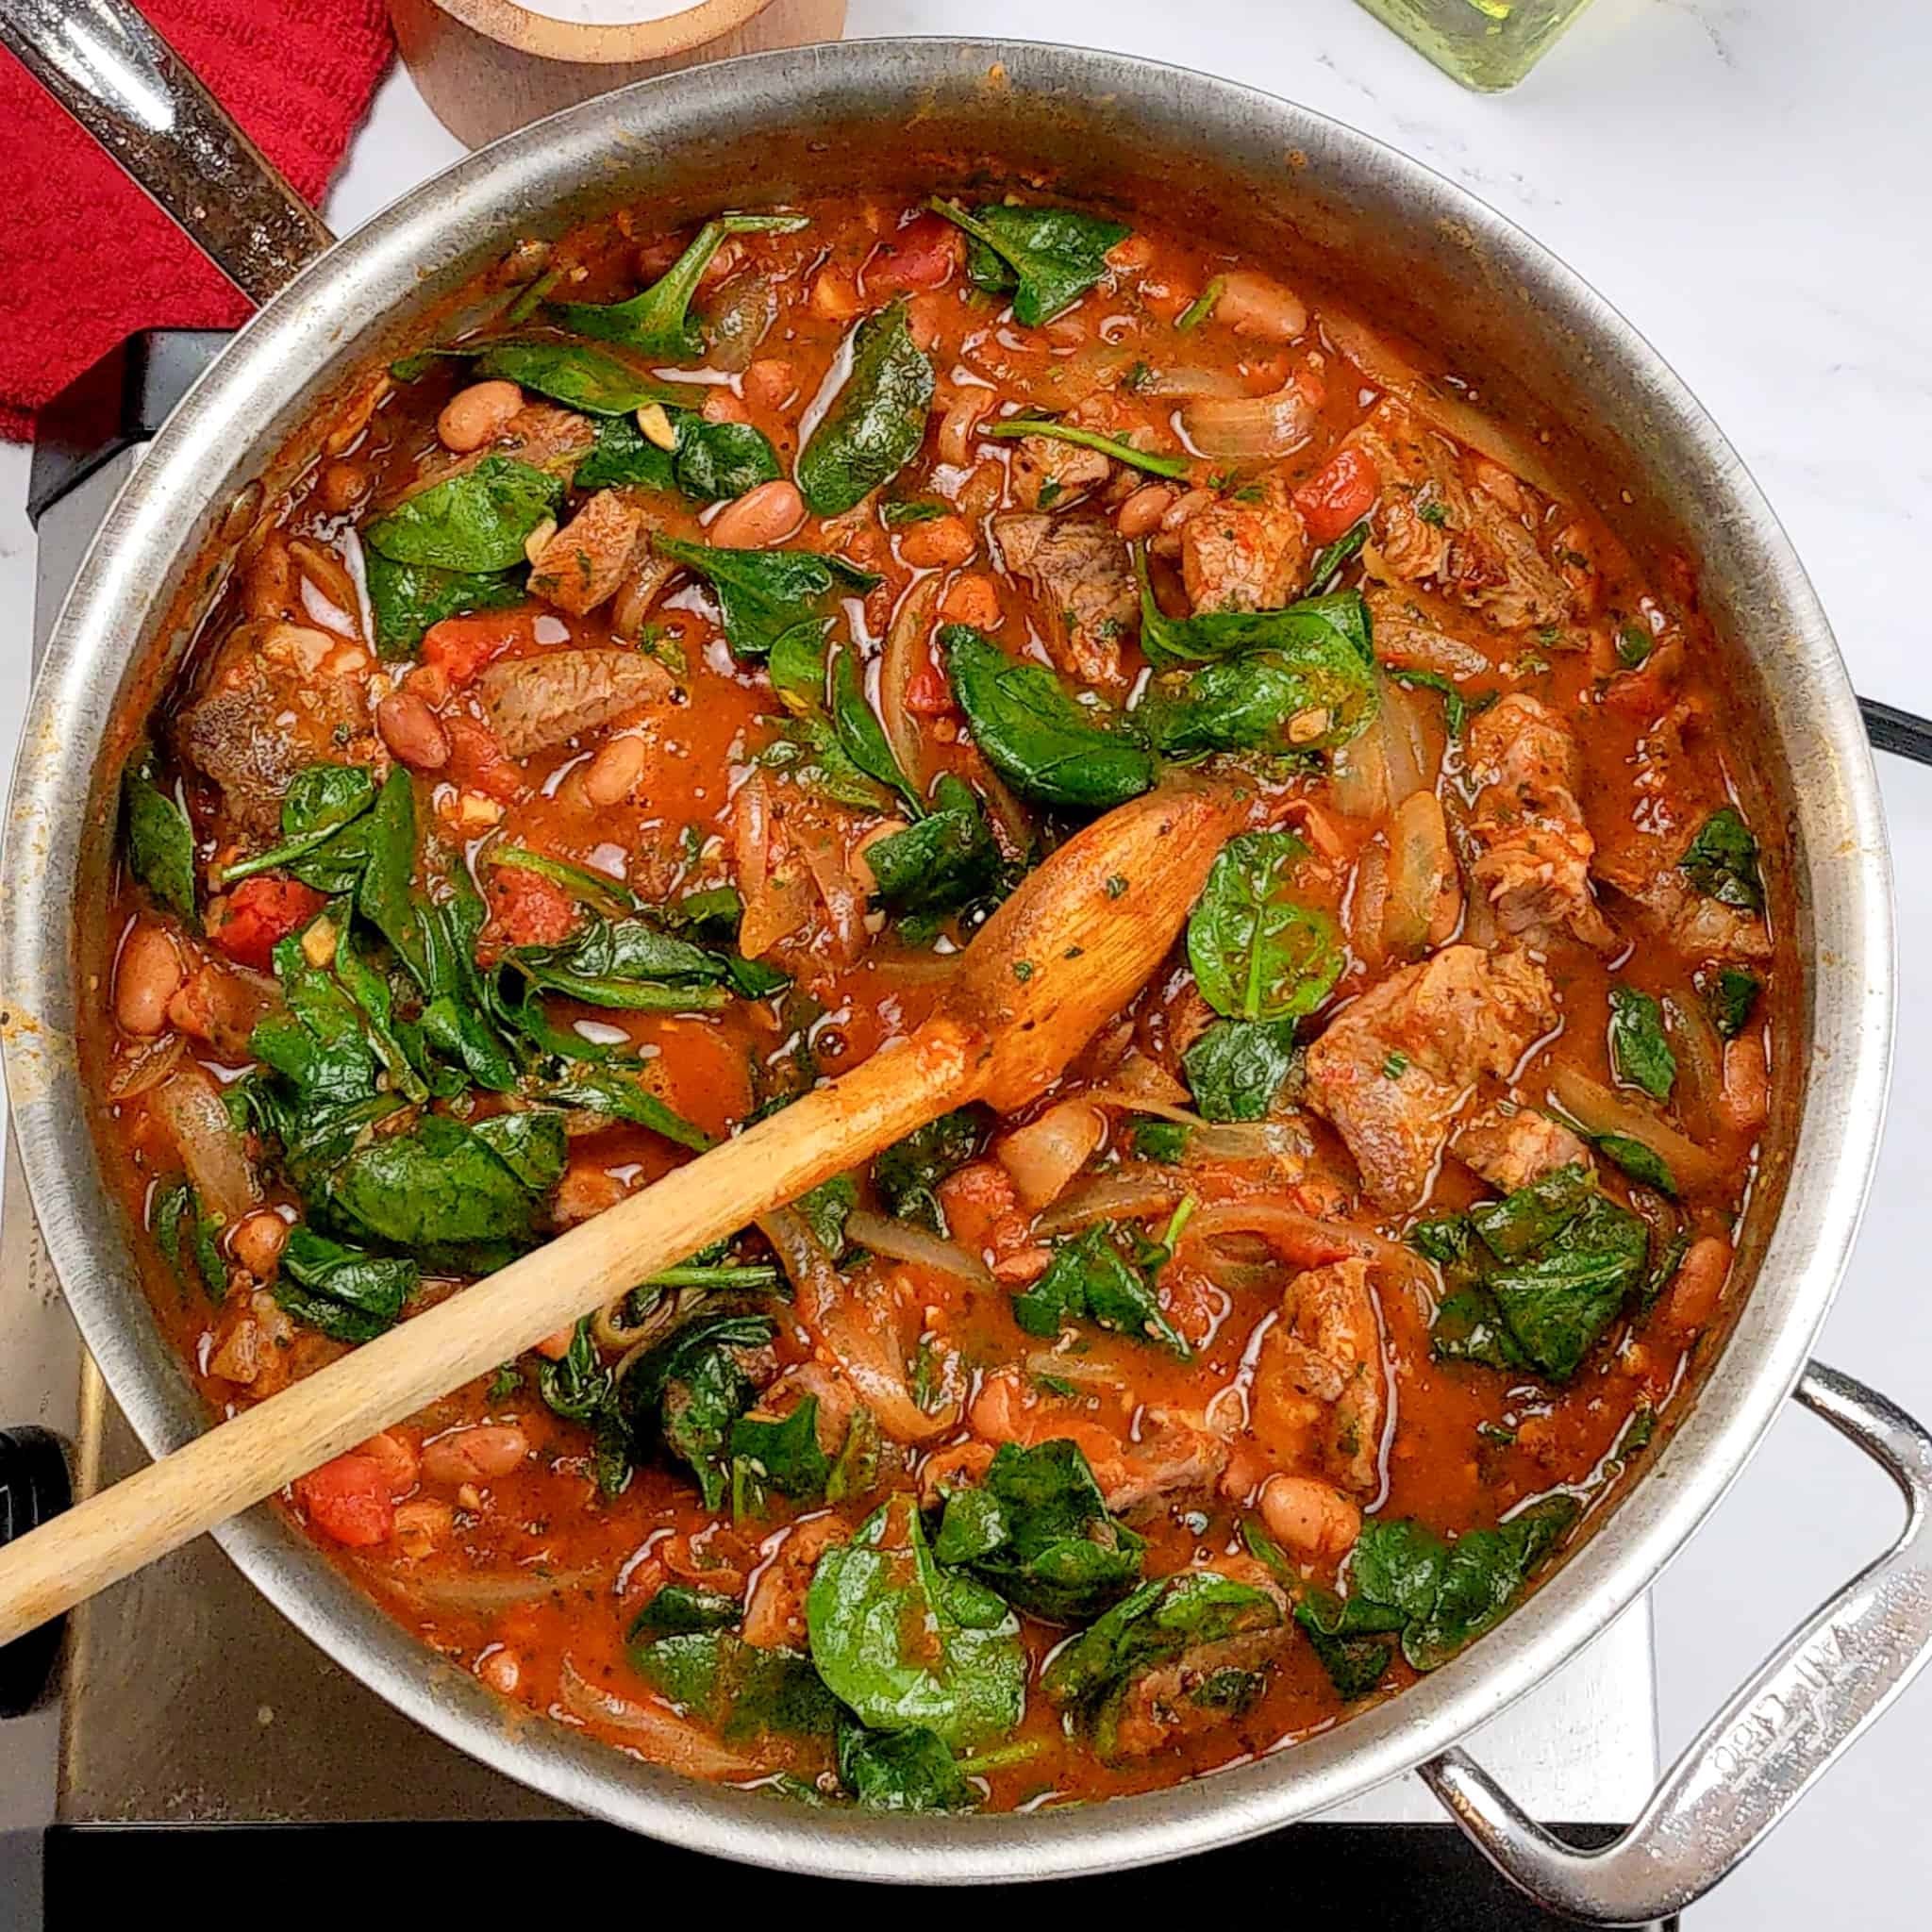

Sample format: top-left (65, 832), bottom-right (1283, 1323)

top-left (1189, 833), bottom-right (1342, 1020)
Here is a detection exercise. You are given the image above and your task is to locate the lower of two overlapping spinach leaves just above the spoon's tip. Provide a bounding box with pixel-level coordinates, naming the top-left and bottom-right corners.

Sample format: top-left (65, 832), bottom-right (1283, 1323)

top-left (1136, 637), bottom-right (1381, 758)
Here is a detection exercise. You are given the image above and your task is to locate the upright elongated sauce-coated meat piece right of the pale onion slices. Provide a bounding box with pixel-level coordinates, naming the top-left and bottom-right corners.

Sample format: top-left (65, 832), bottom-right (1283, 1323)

top-left (1468, 693), bottom-right (1623, 953)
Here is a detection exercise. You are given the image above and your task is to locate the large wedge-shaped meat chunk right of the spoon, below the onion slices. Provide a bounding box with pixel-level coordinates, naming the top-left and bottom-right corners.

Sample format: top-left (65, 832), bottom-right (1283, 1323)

top-left (1306, 944), bottom-right (1557, 1208)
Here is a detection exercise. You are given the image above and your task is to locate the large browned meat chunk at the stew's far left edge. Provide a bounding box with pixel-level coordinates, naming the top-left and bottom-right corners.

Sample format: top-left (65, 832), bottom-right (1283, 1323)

top-left (174, 625), bottom-right (389, 841)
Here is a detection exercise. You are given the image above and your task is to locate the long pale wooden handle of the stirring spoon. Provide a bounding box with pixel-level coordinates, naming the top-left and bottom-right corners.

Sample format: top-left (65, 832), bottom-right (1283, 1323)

top-left (0, 1020), bottom-right (985, 1644)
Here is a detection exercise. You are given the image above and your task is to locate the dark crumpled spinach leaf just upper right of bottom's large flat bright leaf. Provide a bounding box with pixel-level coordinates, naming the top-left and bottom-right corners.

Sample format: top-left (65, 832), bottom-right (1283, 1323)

top-left (933, 1441), bottom-right (1148, 1623)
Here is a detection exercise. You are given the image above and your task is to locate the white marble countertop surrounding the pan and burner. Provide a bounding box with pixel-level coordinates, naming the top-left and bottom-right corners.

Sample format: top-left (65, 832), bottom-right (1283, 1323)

top-left (0, 0), bottom-right (1932, 1932)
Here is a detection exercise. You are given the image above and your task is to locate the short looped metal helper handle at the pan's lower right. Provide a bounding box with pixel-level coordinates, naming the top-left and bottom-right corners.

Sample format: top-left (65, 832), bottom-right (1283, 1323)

top-left (1422, 1362), bottom-right (1932, 1926)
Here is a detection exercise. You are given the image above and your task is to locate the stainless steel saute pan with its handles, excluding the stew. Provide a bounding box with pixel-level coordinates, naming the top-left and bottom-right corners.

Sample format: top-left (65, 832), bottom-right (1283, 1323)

top-left (0, 0), bottom-right (1932, 1924)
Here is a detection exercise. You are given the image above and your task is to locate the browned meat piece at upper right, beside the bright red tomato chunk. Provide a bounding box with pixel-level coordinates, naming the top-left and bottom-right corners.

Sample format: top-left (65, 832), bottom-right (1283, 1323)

top-left (1344, 396), bottom-right (1573, 630)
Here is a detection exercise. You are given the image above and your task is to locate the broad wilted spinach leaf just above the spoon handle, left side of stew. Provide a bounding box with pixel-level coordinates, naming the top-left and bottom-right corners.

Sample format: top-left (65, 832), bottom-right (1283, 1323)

top-left (326, 1112), bottom-right (537, 1274)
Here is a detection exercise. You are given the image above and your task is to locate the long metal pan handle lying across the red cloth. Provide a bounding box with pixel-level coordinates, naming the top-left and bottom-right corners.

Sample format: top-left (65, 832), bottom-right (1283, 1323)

top-left (0, 0), bottom-right (334, 304)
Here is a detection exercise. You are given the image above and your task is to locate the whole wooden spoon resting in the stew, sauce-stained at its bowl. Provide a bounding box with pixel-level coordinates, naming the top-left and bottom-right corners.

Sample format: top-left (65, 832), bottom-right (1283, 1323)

top-left (0, 784), bottom-right (1241, 1644)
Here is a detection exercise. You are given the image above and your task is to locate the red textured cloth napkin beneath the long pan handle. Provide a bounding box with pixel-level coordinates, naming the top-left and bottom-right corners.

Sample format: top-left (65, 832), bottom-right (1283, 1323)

top-left (0, 0), bottom-right (391, 441)
